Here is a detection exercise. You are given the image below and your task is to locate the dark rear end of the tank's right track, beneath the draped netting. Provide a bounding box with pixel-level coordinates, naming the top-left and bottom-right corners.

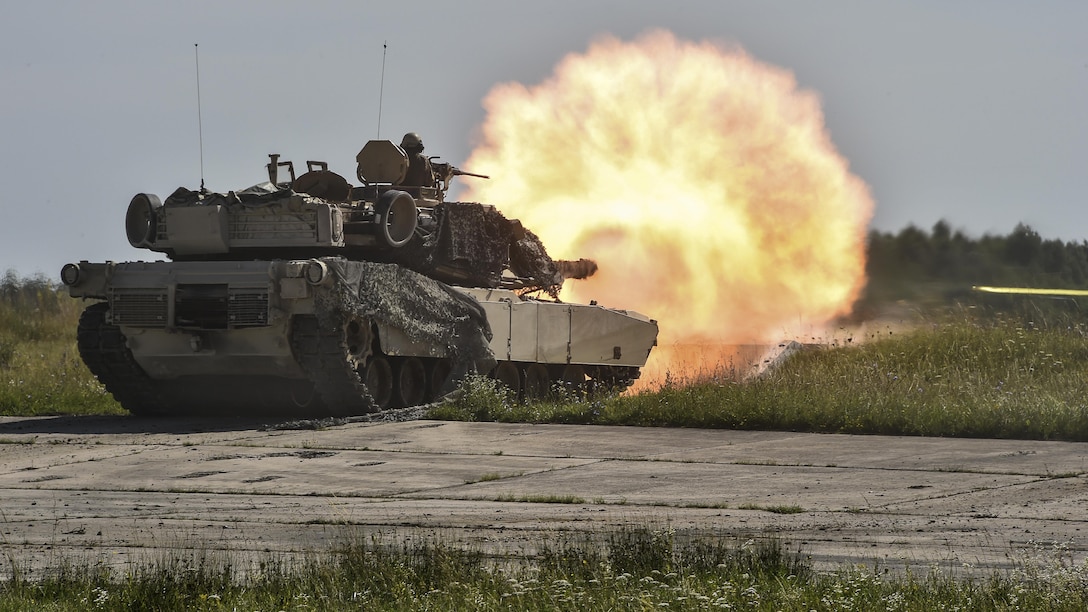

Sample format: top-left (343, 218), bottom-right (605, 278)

top-left (290, 315), bottom-right (379, 416)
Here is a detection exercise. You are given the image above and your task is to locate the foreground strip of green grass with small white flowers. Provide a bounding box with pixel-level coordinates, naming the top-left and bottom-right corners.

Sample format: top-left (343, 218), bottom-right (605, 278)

top-left (6, 527), bottom-right (1088, 611)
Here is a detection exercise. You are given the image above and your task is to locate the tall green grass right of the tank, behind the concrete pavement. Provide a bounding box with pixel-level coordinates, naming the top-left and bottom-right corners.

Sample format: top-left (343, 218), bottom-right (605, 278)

top-left (431, 310), bottom-right (1088, 441)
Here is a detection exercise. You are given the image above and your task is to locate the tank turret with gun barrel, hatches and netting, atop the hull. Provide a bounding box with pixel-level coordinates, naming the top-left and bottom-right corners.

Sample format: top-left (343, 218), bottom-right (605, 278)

top-left (125, 140), bottom-right (596, 295)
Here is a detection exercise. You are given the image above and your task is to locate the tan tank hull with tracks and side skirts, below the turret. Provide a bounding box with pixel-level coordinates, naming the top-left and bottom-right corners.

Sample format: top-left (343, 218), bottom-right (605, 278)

top-left (67, 257), bottom-right (657, 416)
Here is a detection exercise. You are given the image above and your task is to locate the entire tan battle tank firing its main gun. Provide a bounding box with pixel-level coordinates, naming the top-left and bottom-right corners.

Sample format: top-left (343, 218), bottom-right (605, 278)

top-left (61, 140), bottom-right (657, 416)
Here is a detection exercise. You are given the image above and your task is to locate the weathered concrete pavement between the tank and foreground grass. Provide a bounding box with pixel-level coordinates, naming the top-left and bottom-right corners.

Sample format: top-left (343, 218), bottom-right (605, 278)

top-left (0, 417), bottom-right (1088, 573)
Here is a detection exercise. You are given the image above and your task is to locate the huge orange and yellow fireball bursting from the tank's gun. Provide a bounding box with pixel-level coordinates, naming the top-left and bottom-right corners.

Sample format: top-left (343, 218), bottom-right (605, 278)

top-left (465, 32), bottom-right (873, 381)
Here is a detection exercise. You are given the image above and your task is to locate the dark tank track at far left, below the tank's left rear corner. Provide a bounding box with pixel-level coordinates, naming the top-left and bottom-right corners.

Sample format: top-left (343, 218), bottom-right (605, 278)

top-left (76, 302), bottom-right (171, 416)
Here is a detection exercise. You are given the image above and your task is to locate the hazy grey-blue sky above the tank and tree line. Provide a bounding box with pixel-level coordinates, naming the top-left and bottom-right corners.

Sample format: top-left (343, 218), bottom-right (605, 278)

top-left (0, 0), bottom-right (1088, 278)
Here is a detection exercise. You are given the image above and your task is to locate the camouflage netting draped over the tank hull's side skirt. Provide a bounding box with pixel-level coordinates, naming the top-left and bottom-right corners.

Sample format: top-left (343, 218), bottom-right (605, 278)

top-left (314, 257), bottom-right (495, 391)
